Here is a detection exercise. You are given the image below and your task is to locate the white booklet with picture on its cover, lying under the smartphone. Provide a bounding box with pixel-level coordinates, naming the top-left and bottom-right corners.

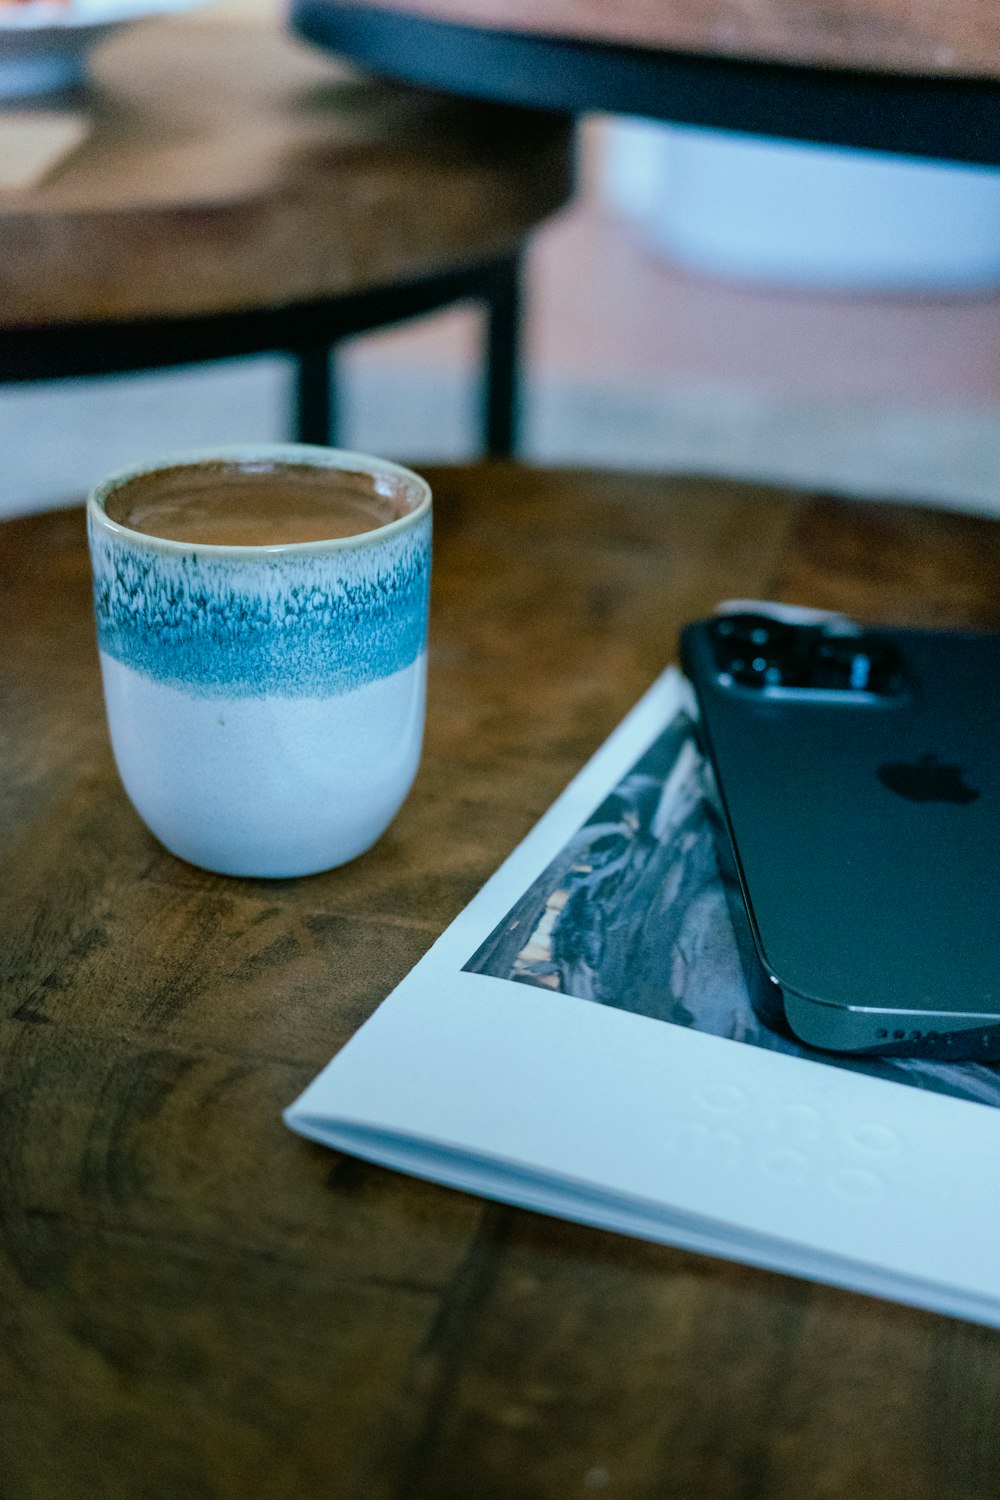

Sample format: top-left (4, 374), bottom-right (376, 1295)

top-left (285, 671), bottom-right (1000, 1326)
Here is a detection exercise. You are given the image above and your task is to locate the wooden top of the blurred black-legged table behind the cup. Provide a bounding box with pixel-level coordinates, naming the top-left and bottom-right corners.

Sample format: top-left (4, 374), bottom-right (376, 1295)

top-left (0, 21), bottom-right (573, 327)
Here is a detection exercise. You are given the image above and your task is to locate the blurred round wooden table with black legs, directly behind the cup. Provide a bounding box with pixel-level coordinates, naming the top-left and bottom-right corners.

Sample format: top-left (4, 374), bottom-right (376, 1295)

top-left (0, 20), bottom-right (573, 455)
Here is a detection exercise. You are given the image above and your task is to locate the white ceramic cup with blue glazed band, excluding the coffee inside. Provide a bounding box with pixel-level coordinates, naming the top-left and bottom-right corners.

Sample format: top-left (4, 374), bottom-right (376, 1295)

top-left (87, 444), bottom-right (430, 878)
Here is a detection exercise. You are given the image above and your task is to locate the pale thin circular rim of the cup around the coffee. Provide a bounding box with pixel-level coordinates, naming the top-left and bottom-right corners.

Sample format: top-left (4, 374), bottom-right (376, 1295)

top-left (87, 443), bottom-right (432, 561)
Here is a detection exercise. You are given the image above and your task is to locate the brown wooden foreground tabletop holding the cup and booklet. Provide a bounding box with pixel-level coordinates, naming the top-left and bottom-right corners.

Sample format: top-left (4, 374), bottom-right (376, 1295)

top-left (0, 468), bottom-right (1000, 1500)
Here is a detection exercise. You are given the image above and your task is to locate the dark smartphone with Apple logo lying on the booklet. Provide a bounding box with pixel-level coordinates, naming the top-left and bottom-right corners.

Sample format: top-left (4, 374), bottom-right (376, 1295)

top-left (681, 603), bottom-right (1000, 1062)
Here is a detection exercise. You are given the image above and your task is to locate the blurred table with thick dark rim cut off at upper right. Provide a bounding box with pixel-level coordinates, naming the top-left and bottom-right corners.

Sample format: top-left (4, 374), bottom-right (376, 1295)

top-left (292, 0), bottom-right (1000, 165)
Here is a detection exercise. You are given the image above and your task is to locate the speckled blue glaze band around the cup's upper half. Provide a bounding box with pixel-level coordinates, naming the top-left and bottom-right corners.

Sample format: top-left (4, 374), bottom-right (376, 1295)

top-left (88, 515), bottom-right (430, 698)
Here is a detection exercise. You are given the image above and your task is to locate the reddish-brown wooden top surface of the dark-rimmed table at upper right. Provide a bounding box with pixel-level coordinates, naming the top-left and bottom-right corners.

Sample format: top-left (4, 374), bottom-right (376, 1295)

top-left (344, 0), bottom-right (1000, 78)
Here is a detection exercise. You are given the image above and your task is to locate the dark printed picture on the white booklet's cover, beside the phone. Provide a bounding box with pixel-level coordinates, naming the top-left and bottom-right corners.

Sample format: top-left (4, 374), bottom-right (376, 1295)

top-left (465, 714), bottom-right (1000, 1107)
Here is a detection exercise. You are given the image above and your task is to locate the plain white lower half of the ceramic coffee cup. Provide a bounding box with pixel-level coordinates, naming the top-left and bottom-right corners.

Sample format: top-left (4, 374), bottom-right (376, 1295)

top-left (100, 653), bottom-right (426, 879)
